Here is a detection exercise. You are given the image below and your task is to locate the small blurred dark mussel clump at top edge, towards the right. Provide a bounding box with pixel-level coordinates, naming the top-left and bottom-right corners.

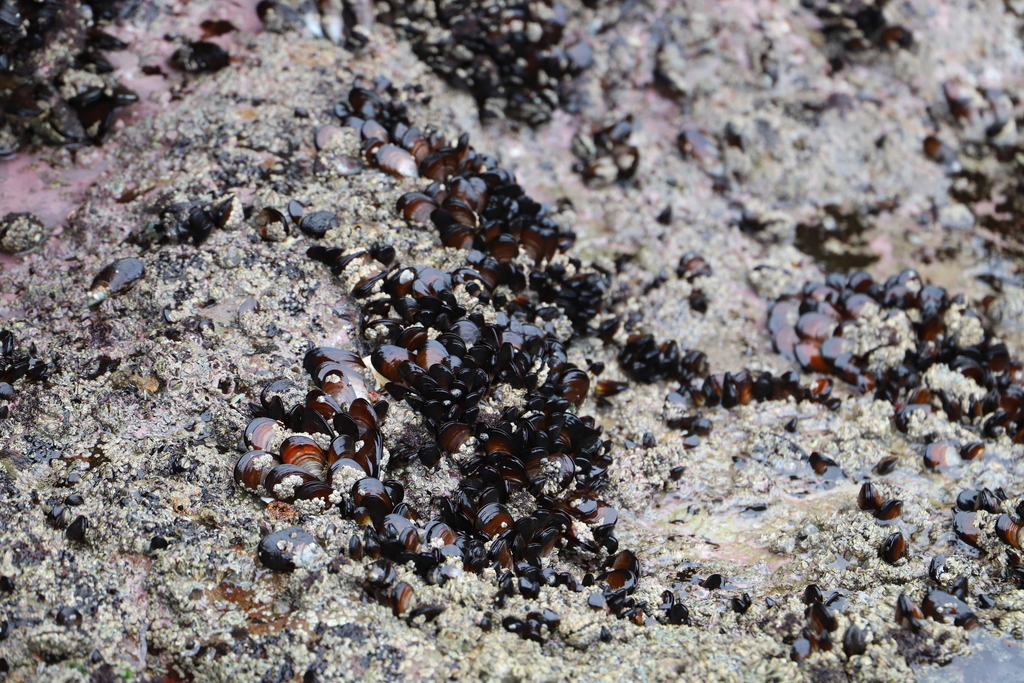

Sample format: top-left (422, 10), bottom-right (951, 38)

top-left (801, 0), bottom-right (913, 52)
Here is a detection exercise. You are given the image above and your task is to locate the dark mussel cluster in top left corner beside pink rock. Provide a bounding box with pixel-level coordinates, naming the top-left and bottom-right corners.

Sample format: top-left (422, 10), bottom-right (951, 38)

top-left (0, 0), bottom-right (138, 150)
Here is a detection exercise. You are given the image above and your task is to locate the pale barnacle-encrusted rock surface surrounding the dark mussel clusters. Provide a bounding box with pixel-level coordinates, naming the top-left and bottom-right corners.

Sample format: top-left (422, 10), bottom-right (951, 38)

top-left (0, 0), bottom-right (1024, 682)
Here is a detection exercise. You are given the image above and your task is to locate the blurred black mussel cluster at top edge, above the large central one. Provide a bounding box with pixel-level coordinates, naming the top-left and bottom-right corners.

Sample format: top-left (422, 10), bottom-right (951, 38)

top-left (379, 0), bottom-right (593, 125)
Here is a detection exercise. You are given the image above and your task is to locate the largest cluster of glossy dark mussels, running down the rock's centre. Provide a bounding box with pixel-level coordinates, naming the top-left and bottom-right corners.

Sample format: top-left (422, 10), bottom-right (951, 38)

top-left (234, 80), bottom-right (642, 637)
